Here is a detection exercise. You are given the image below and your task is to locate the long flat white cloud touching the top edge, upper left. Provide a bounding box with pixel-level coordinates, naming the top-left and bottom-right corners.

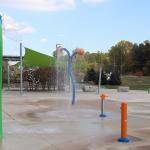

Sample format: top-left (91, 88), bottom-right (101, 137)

top-left (0, 0), bottom-right (75, 11)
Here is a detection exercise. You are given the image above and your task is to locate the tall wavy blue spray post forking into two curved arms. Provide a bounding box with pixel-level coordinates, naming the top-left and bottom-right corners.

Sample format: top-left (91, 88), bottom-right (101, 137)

top-left (57, 47), bottom-right (84, 105)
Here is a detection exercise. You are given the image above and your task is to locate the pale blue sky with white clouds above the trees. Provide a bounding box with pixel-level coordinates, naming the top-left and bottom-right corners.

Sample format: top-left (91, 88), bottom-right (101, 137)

top-left (0, 0), bottom-right (150, 55)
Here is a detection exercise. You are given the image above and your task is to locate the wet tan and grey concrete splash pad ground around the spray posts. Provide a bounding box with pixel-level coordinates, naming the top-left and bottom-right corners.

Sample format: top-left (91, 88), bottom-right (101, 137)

top-left (0, 89), bottom-right (150, 150)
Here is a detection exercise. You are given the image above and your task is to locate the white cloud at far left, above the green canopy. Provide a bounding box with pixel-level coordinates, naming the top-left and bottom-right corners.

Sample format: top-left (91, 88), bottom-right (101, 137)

top-left (3, 15), bottom-right (36, 35)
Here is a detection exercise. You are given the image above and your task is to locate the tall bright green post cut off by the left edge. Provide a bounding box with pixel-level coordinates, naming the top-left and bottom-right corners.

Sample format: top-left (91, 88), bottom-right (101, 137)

top-left (0, 15), bottom-right (3, 139)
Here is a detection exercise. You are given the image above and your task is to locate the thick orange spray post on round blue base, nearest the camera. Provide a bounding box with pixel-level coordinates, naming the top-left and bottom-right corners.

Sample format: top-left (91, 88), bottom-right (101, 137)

top-left (118, 102), bottom-right (130, 142)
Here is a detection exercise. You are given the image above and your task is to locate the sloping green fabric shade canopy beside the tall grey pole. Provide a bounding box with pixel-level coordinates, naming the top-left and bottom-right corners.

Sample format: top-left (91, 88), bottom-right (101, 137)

top-left (23, 48), bottom-right (55, 67)
